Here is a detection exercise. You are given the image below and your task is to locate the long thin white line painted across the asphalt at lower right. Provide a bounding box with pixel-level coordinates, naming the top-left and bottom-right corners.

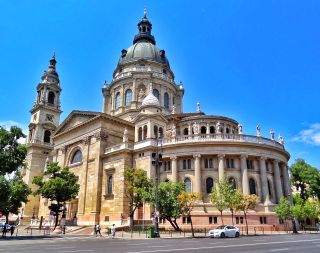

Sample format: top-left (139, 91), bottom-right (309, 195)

top-left (127, 239), bottom-right (320, 253)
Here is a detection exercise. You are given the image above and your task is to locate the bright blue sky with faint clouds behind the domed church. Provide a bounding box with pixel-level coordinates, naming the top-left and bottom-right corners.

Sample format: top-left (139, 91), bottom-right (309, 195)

top-left (0, 0), bottom-right (320, 168)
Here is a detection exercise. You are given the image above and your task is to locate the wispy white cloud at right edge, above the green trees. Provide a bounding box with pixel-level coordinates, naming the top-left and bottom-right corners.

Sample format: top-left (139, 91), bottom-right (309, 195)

top-left (292, 123), bottom-right (320, 146)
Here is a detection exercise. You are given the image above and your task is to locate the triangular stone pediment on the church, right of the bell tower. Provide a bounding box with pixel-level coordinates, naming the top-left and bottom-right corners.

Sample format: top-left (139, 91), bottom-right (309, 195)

top-left (55, 111), bottom-right (100, 135)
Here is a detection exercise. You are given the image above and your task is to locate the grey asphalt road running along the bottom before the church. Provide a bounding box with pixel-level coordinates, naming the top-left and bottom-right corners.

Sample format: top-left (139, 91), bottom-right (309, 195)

top-left (0, 234), bottom-right (320, 253)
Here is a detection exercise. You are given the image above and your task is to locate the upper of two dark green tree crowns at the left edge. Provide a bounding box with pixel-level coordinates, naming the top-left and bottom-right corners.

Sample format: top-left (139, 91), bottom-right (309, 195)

top-left (0, 126), bottom-right (27, 175)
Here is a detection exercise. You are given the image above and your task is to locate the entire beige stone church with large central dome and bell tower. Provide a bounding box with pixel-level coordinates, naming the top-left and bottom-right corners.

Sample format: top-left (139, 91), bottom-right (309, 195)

top-left (24, 13), bottom-right (291, 228)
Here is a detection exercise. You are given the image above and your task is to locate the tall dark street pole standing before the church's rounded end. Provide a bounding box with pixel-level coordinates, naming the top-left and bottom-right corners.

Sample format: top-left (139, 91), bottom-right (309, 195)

top-left (151, 131), bottom-right (162, 237)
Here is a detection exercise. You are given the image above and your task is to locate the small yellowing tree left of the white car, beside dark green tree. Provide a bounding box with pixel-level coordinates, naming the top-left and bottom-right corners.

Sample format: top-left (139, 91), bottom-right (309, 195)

top-left (177, 192), bottom-right (199, 237)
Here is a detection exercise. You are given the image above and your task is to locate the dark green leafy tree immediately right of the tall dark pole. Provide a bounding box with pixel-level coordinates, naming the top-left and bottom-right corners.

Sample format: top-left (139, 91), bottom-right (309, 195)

top-left (158, 181), bottom-right (185, 231)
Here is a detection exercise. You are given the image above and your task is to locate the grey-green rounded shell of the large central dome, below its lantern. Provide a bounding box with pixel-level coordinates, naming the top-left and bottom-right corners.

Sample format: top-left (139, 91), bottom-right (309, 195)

top-left (119, 41), bottom-right (169, 66)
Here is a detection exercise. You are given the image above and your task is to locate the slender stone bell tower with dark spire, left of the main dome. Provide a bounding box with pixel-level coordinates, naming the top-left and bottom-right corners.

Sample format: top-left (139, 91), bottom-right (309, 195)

top-left (22, 53), bottom-right (62, 218)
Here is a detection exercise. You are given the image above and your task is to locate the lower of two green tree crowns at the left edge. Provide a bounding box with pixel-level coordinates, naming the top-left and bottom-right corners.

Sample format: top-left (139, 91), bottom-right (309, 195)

top-left (0, 172), bottom-right (31, 221)
